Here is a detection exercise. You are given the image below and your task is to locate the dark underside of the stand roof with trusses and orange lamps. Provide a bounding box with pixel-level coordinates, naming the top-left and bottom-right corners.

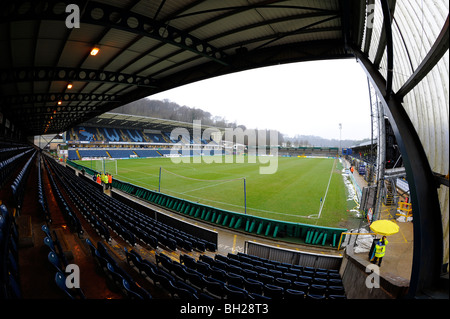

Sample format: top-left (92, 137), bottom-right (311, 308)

top-left (0, 0), bottom-right (365, 135)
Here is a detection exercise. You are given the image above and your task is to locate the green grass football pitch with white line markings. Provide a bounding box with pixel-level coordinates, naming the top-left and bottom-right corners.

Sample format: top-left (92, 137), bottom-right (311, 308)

top-left (78, 157), bottom-right (349, 227)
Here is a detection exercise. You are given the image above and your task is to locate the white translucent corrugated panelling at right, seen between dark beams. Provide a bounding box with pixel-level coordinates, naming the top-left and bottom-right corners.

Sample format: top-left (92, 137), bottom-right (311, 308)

top-left (369, 0), bottom-right (449, 268)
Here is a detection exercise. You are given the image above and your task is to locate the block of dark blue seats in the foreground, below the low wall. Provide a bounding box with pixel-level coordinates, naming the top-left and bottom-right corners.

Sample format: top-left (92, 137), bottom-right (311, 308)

top-left (118, 250), bottom-right (346, 300)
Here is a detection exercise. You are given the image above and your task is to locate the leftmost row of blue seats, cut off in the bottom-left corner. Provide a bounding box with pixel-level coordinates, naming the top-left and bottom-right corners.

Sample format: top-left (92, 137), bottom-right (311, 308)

top-left (0, 205), bottom-right (22, 299)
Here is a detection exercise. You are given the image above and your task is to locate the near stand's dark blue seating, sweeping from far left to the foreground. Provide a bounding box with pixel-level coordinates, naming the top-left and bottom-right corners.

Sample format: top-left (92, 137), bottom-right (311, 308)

top-left (0, 142), bottom-right (345, 300)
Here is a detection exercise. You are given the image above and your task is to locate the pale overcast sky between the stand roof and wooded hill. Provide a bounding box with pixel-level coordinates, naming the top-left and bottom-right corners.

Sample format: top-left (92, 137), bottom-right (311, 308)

top-left (149, 59), bottom-right (371, 140)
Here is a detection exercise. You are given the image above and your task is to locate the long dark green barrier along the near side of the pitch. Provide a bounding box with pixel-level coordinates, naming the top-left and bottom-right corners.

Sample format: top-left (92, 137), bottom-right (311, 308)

top-left (67, 161), bottom-right (347, 249)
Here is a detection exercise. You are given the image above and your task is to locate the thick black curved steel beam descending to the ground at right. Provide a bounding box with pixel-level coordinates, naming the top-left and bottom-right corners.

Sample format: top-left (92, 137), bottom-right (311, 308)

top-left (353, 47), bottom-right (443, 297)
